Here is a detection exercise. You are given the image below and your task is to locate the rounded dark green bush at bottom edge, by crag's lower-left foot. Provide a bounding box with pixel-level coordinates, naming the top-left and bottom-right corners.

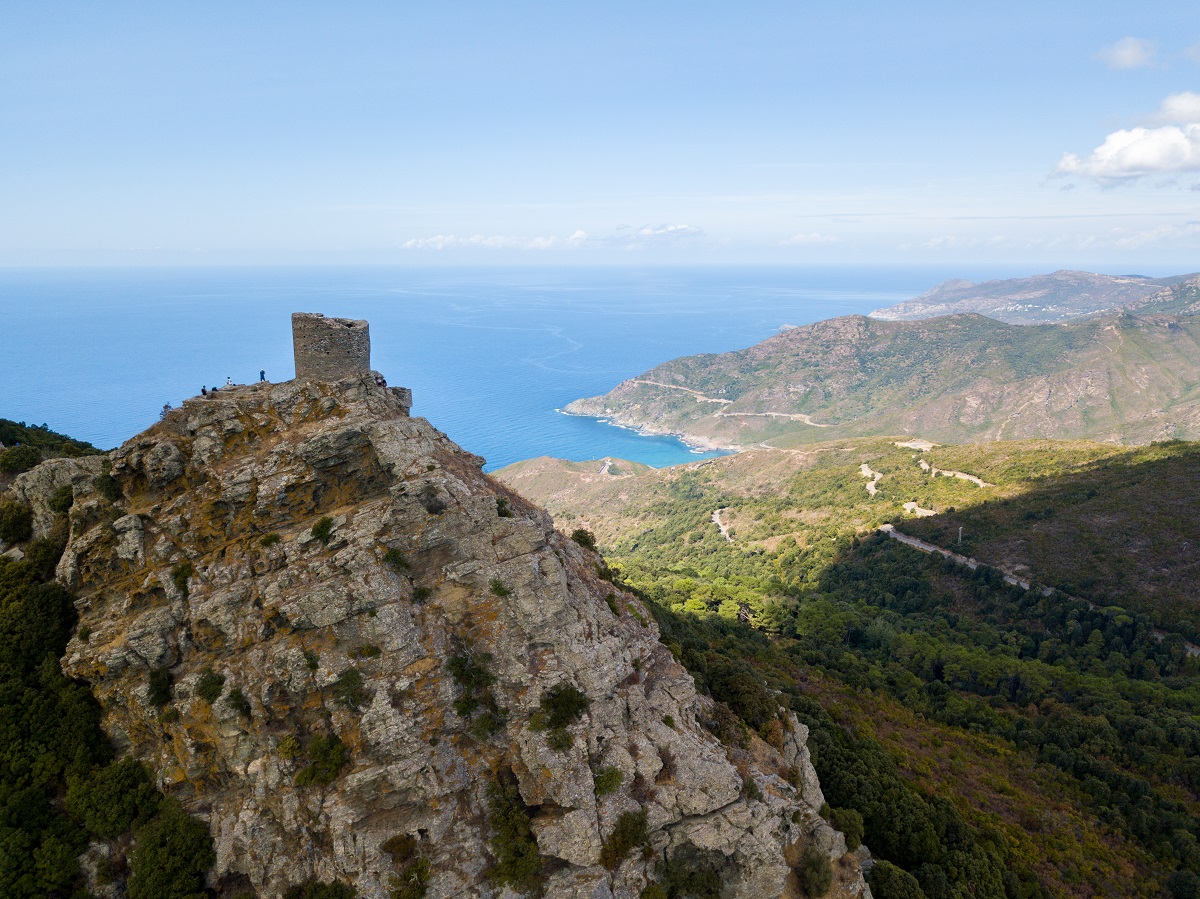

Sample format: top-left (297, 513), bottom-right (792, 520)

top-left (127, 799), bottom-right (216, 899)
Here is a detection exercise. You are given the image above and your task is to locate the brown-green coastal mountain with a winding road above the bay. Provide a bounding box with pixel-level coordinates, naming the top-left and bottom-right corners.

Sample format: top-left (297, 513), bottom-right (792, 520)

top-left (565, 309), bottom-right (1200, 449)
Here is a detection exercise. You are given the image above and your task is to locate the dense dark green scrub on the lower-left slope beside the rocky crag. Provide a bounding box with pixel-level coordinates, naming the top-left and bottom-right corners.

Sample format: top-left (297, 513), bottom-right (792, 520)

top-left (0, 496), bottom-right (215, 899)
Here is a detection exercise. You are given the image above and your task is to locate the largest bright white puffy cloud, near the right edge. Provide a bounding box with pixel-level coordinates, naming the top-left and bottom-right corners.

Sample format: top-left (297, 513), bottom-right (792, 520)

top-left (1054, 125), bottom-right (1200, 182)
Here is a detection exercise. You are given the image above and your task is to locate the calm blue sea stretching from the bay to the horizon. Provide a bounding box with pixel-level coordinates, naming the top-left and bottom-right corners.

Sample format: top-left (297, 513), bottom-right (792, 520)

top-left (0, 266), bottom-right (1027, 469)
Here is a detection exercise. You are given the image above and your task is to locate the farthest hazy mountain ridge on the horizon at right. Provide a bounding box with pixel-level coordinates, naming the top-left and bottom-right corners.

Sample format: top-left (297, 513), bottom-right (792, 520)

top-left (871, 270), bottom-right (1200, 324)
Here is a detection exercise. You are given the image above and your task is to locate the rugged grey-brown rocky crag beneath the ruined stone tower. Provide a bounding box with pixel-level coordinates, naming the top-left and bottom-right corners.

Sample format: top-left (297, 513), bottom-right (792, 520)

top-left (54, 374), bottom-right (869, 899)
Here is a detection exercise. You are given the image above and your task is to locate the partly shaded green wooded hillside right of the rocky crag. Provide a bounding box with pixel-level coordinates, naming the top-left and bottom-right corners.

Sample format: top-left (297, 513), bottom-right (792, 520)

top-left (498, 439), bottom-right (1200, 899)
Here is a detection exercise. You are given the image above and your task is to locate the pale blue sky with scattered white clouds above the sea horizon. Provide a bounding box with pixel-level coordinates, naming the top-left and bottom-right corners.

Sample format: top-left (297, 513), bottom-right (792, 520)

top-left (0, 0), bottom-right (1200, 272)
